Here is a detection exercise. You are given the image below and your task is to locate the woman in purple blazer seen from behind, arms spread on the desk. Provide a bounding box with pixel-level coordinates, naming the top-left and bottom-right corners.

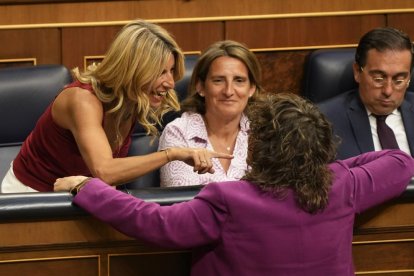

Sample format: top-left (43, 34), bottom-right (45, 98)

top-left (55, 94), bottom-right (414, 276)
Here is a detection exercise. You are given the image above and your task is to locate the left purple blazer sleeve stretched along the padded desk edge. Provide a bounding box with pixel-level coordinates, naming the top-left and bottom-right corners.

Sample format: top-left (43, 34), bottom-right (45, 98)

top-left (73, 178), bottom-right (224, 248)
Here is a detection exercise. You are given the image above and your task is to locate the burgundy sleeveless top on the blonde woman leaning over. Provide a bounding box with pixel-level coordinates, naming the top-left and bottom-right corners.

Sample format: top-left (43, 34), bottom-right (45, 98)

top-left (13, 81), bottom-right (134, 192)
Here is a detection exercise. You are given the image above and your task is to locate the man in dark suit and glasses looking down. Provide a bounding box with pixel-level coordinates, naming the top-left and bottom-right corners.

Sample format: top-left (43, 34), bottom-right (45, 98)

top-left (319, 27), bottom-right (414, 159)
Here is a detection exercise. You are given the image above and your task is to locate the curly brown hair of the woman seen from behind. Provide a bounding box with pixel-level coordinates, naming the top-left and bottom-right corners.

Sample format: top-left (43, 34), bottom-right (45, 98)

top-left (243, 93), bottom-right (336, 213)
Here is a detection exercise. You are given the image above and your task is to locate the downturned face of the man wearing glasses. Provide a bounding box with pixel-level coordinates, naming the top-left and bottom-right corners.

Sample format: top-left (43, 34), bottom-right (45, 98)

top-left (354, 49), bottom-right (411, 115)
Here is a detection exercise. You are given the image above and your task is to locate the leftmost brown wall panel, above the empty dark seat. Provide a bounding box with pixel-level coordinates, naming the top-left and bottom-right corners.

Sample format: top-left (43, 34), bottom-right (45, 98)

top-left (0, 28), bottom-right (62, 64)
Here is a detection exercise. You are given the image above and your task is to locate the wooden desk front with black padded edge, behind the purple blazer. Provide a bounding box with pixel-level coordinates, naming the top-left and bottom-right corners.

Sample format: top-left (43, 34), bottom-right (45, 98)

top-left (0, 184), bottom-right (414, 276)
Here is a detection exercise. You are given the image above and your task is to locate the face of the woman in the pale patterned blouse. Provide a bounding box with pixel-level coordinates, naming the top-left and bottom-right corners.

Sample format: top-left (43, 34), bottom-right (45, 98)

top-left (197, 56), bottom-right (256, 120)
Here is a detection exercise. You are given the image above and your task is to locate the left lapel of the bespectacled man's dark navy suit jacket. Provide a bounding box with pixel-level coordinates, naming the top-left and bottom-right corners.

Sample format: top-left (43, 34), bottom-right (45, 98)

top-left (347, 91), bottom-right (376, 153)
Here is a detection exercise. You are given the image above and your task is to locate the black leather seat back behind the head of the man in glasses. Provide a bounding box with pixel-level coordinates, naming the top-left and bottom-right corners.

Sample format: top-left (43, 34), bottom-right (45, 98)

top-left (302, 48), bottom-right (414, 103)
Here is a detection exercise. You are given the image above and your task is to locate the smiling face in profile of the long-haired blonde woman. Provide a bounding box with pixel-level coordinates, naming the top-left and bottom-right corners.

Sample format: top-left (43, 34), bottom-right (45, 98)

top-left (148, 54), bottom-right (175, 108)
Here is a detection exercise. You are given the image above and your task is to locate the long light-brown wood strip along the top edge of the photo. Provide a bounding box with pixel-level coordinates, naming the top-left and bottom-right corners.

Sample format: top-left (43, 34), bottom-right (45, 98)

top-left (0, 0), bottom-right (413, 25)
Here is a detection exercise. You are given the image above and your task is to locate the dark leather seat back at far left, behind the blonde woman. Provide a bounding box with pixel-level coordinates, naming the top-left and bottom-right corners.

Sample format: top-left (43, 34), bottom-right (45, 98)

top-left (0, 65), bottom-right (72, 181)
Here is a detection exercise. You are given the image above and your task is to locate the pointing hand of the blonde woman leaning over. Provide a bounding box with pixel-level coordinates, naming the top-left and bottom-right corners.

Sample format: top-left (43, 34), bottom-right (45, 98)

top-left (168, 148), bottom-right (233, 174)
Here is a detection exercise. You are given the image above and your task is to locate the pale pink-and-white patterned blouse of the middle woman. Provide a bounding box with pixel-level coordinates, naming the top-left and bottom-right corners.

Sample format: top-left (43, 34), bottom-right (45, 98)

top-left (158, 112), bottom-right (250, 187)
